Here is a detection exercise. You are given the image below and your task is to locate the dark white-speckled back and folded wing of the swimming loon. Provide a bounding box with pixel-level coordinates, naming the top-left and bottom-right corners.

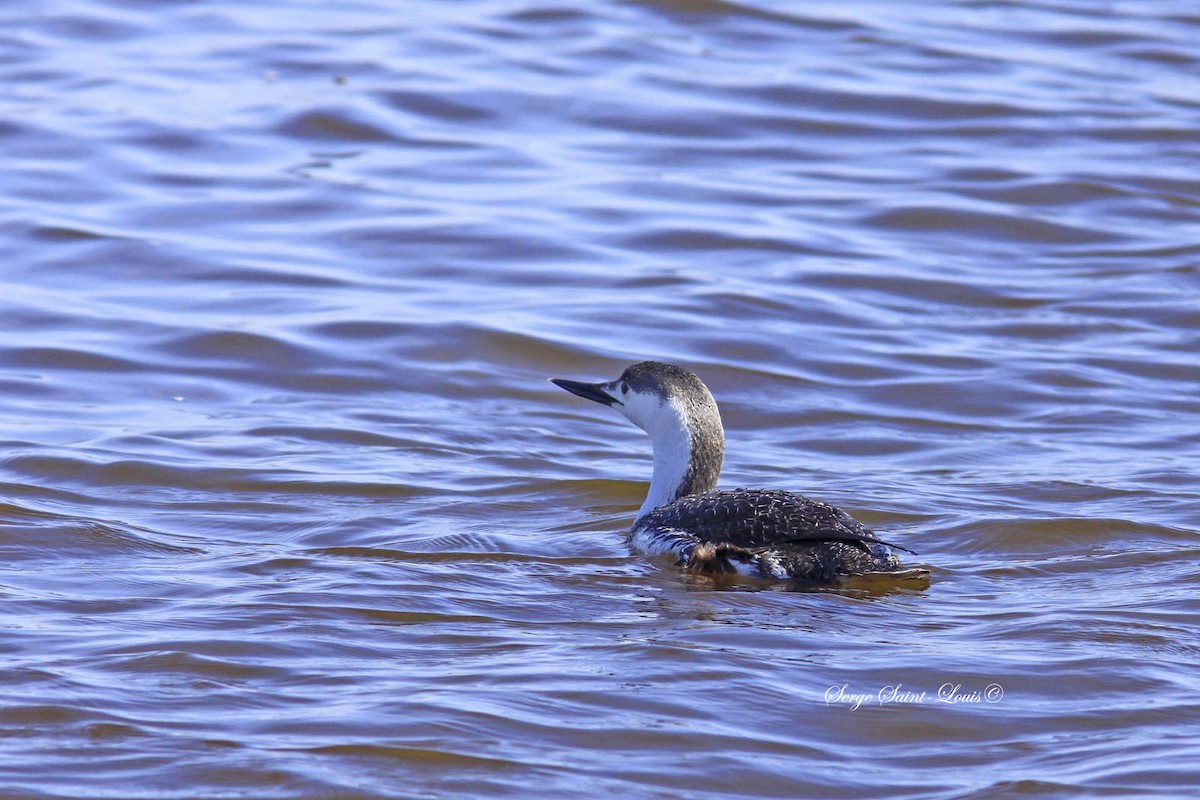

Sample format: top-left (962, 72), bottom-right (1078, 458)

top-left (638, 489), bottom-right (912, 553)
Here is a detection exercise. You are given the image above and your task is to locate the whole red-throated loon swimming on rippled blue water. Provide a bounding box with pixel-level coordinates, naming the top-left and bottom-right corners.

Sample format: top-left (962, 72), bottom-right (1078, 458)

top-left (551, 361), bottom-right (912, 583)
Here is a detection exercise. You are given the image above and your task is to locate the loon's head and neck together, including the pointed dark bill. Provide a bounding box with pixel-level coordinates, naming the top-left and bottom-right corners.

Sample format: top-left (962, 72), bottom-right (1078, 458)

top-left (551, 361), bottom-right (725, 517)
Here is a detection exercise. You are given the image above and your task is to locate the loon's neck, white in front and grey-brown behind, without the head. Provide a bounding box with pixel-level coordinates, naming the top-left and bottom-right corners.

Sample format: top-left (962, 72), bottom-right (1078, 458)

top-left (637, 398), bottom-right (725, 519)
